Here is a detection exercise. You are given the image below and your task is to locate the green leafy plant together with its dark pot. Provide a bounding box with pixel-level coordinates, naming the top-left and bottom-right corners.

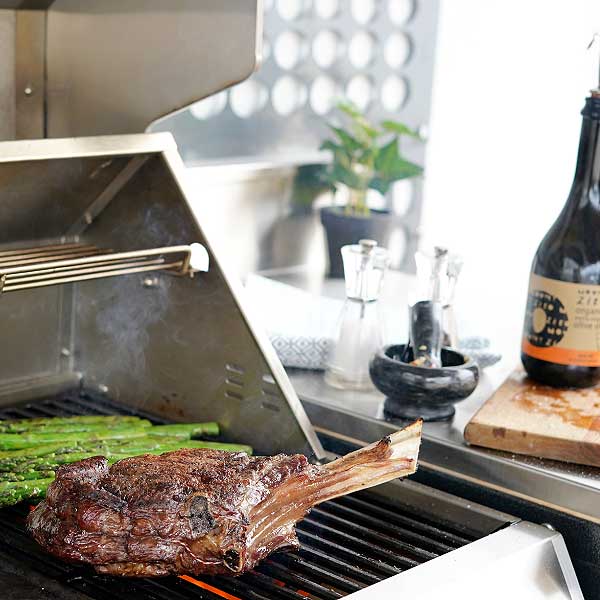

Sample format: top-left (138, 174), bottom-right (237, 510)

top-left (321, 102), bottom-right (423, 277)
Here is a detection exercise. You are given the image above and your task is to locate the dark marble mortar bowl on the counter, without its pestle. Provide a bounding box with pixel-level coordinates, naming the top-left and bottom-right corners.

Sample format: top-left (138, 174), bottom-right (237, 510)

top-left (369, 344), bottom-right (479, 421)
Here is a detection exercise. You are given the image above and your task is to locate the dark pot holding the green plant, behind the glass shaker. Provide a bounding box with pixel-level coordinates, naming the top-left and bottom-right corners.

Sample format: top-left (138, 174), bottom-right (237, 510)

top-left (321, 206), bottom-right (398, 278)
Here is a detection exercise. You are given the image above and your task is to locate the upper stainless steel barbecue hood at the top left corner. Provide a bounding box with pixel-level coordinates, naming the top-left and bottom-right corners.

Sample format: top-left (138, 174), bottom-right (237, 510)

top-left (0, 0), bottom-right (262, 139)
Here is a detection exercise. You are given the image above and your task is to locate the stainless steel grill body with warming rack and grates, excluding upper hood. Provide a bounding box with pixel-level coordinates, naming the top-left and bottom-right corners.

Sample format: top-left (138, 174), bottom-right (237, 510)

top-left (0, 129), bottom-right (580, 600)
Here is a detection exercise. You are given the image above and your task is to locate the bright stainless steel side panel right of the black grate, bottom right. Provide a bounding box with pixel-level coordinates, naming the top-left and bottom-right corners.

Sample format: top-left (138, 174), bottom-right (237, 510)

top-left (348, 522), bottom-right (583, 600)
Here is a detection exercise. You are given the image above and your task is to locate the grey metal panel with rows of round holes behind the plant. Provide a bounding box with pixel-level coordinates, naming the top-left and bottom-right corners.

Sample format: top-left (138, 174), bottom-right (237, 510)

top-left (152, 0), bottom-right (438, 266)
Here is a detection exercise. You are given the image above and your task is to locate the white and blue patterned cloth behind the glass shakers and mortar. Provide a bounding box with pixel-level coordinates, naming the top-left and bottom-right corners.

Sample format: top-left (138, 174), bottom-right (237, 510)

top-left (246, 275), bottom-right (501, 370)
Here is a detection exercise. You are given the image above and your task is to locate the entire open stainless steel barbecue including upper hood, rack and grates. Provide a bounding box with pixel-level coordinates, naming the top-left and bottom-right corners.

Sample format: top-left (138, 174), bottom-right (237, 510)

top-left (0, 0), bottom-right (581, 600)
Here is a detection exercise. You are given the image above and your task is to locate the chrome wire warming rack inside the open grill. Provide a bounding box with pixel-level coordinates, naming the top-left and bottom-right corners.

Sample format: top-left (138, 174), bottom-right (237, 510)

top-left (0, 243), bottom-right (198, 292)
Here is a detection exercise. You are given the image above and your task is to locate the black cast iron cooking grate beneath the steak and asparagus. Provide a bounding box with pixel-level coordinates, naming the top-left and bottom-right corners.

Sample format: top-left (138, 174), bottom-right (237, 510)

top-left (0, 392), bottom-right (475, 600)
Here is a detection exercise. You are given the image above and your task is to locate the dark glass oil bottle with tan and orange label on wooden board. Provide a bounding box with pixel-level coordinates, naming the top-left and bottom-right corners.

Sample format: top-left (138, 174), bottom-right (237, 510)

top-left (521, 89), bottom-right (600, 387)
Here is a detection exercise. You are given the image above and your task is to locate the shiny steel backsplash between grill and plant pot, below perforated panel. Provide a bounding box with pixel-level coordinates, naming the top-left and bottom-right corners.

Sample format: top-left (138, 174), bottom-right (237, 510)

top-left (188, 163), bottom-right (326, 278)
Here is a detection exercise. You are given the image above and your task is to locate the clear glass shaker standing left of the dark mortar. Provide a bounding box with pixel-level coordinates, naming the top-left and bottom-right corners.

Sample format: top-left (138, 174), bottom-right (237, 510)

top-left (325, 240), bottom-right (389, 390)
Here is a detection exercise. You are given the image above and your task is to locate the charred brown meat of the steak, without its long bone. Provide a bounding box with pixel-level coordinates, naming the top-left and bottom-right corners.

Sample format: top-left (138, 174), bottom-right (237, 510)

top-left (27, 449), bottom-right (318, 576)
